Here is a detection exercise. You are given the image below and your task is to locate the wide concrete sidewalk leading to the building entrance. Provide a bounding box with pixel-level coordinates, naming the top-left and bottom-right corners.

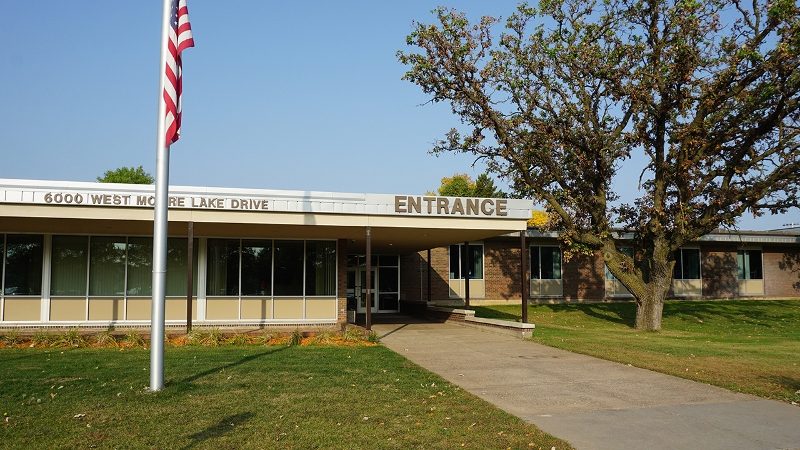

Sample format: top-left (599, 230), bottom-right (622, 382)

top-left (373, 323), bottom-right (800, 450)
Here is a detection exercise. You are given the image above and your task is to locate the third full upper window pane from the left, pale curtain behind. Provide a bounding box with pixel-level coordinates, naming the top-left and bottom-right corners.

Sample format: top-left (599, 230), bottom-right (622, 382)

top-left (89, 236), bottom-right (126, 295)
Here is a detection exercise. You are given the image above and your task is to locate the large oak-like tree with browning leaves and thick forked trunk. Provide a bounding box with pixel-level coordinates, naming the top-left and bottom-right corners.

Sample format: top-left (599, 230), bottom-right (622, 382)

top-left (398, 0), bottom-right (800, 330)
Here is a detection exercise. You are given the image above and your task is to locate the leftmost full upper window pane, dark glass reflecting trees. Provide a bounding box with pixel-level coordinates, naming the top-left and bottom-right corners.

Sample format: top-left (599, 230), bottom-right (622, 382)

top-left (0, 234), bottom-right (44, 295)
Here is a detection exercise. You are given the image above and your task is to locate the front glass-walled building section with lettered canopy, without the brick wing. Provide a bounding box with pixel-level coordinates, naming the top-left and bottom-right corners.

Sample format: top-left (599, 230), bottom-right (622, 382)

top-left (0, 180), bottom-right (532, 327)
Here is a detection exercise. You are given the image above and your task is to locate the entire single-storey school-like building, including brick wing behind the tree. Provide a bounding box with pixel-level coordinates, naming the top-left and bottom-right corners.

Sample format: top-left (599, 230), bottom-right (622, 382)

top-left (0, 180), bottom-right (800, 328)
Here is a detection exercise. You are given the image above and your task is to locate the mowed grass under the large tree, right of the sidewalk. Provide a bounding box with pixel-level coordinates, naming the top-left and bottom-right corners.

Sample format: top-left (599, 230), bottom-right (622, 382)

top-left (474, 300), bottom-right (800, 402)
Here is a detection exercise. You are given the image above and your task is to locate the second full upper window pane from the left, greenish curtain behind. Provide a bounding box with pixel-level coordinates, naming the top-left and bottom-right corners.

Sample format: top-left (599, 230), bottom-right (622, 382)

top-left (50, 236), bottom-right (89, 295)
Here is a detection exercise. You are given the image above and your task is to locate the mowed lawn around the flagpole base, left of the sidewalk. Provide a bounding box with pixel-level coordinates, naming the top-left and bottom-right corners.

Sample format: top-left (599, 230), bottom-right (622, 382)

top-left (0, 345), bottom-right (571, 450)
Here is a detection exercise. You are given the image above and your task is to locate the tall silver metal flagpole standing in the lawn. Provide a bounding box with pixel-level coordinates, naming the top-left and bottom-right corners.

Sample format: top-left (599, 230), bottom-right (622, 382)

top-left (149, 0), bottom-right (172, 392)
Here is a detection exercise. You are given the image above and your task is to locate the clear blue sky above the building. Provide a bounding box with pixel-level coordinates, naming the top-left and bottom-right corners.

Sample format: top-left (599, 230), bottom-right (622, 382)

top-left (0, 0), bottom-right (800, 229)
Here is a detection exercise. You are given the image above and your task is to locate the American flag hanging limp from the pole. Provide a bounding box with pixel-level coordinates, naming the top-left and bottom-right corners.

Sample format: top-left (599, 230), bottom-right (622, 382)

top-left (164, 0), bottom-right (194, 147)
